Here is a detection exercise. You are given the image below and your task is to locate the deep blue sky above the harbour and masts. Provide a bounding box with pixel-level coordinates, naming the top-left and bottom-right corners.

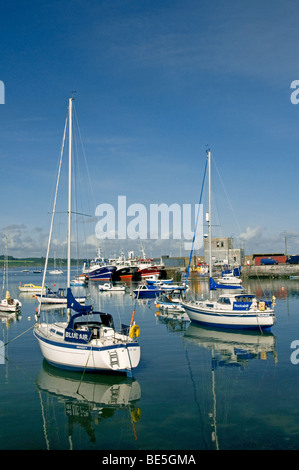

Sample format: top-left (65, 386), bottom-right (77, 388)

top-left (0, 0), bottom-right (299, 257)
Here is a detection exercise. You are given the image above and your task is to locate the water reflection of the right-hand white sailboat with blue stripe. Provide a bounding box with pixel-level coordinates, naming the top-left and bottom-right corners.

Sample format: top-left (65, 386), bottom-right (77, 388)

top-left (184, 324), bottom-right (277, 450)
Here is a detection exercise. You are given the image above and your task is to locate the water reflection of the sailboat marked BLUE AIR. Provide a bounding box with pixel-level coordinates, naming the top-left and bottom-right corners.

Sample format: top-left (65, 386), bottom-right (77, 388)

top-left (36, 362), bottom-right (141, 449)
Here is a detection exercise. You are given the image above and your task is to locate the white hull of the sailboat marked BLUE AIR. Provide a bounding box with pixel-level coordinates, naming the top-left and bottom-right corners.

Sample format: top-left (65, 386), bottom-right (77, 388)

top-left (33, 324), bottom-right (140, 375)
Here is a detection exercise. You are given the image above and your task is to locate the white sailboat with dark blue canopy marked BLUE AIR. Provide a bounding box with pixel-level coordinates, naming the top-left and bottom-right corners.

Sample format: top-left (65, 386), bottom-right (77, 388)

top-left (34, 98), bottom-right (140, 376)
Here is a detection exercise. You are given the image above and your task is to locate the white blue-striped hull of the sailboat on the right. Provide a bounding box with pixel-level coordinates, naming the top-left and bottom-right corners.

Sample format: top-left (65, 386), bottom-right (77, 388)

top-left (182, 302), bottom-right (275, 329)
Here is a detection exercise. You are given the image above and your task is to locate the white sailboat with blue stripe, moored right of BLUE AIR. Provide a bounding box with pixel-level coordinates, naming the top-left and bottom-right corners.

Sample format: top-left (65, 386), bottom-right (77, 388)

top-left (182, 150), bottom-right (275, 329)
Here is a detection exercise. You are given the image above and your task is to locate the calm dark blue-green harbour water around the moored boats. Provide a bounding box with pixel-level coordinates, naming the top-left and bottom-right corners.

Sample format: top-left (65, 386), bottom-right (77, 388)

top-left (0, 269), bottom-right (299, 451)
